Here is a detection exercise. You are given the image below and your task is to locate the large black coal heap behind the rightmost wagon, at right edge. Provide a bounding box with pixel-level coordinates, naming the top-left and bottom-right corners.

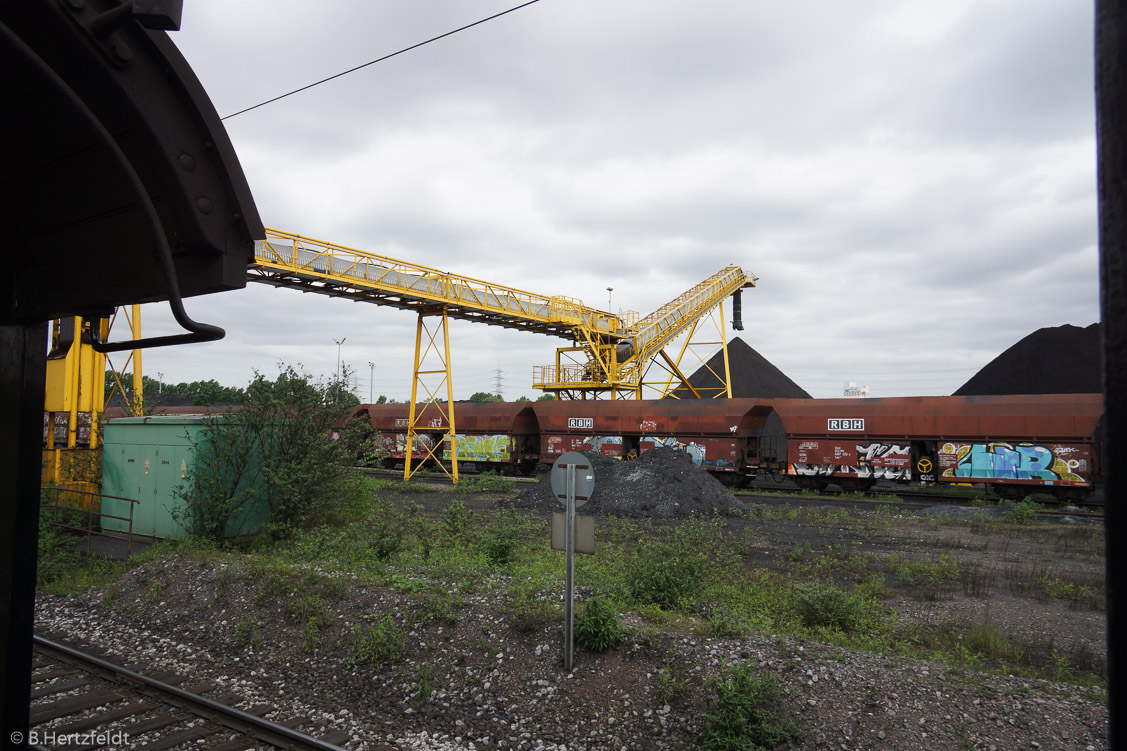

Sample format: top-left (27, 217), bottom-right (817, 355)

top-left (955, 324), bottom-right (1101, 396)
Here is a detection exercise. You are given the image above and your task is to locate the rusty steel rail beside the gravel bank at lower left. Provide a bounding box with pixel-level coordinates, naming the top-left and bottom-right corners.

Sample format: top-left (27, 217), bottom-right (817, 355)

top-left (32, 634), bottom-right (345, 751)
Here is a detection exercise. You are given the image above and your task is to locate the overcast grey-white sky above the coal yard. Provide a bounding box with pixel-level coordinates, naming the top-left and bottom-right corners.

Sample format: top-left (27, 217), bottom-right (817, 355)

top-left (125, 0), bottom-right (1099, 400)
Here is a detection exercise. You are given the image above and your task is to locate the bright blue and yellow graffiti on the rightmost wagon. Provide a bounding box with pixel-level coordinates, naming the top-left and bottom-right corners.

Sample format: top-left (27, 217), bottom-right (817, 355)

top-left (939, 442), bottom-right (1091, 485)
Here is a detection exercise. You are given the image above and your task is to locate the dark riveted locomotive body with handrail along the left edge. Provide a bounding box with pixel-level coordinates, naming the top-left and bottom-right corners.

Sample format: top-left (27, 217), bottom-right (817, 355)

top-left (0, 0), bottom-right (265, 748)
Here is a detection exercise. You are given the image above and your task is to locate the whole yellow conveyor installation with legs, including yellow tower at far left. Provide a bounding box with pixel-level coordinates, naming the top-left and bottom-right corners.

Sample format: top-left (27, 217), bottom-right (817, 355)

top-left (44, 228), bottom-right (756, 485)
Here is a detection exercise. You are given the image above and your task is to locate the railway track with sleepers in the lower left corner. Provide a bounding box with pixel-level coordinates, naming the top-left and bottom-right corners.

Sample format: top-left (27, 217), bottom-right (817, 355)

top-left (28, 634), bottom-right (348, 751)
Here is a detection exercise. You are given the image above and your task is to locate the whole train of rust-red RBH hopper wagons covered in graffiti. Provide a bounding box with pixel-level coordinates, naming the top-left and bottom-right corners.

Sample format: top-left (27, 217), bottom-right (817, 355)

top-left (350, 394), bottom-right (1103, 501)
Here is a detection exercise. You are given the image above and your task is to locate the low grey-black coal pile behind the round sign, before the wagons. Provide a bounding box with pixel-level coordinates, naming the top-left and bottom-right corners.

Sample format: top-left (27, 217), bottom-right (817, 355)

top-left (503, 449), bottom-right (747, 519)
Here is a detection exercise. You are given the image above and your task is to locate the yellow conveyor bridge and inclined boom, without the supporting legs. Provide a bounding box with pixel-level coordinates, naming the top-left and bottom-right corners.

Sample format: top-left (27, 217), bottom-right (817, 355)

top-left (248, 228), bottom-right (755, 398)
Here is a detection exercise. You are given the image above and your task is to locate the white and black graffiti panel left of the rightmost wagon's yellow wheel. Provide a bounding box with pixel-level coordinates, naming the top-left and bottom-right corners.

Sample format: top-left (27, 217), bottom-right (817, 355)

top-left (788, 440), bottom-right (912, 480)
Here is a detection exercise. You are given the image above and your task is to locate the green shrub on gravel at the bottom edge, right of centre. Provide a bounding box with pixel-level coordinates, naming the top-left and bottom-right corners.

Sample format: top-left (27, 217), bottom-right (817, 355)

top-left (703, 660), bottom-right (800, 751)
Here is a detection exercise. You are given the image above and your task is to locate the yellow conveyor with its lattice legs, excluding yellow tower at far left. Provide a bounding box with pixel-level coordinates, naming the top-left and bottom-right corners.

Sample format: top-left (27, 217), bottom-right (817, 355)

top-left (248, 228), bottom-right (755, 481)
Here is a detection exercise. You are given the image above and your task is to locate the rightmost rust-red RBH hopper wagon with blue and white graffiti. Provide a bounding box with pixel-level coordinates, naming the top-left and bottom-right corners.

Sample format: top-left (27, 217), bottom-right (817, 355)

top-left (773, 394), bottom-right (1103, 500)
